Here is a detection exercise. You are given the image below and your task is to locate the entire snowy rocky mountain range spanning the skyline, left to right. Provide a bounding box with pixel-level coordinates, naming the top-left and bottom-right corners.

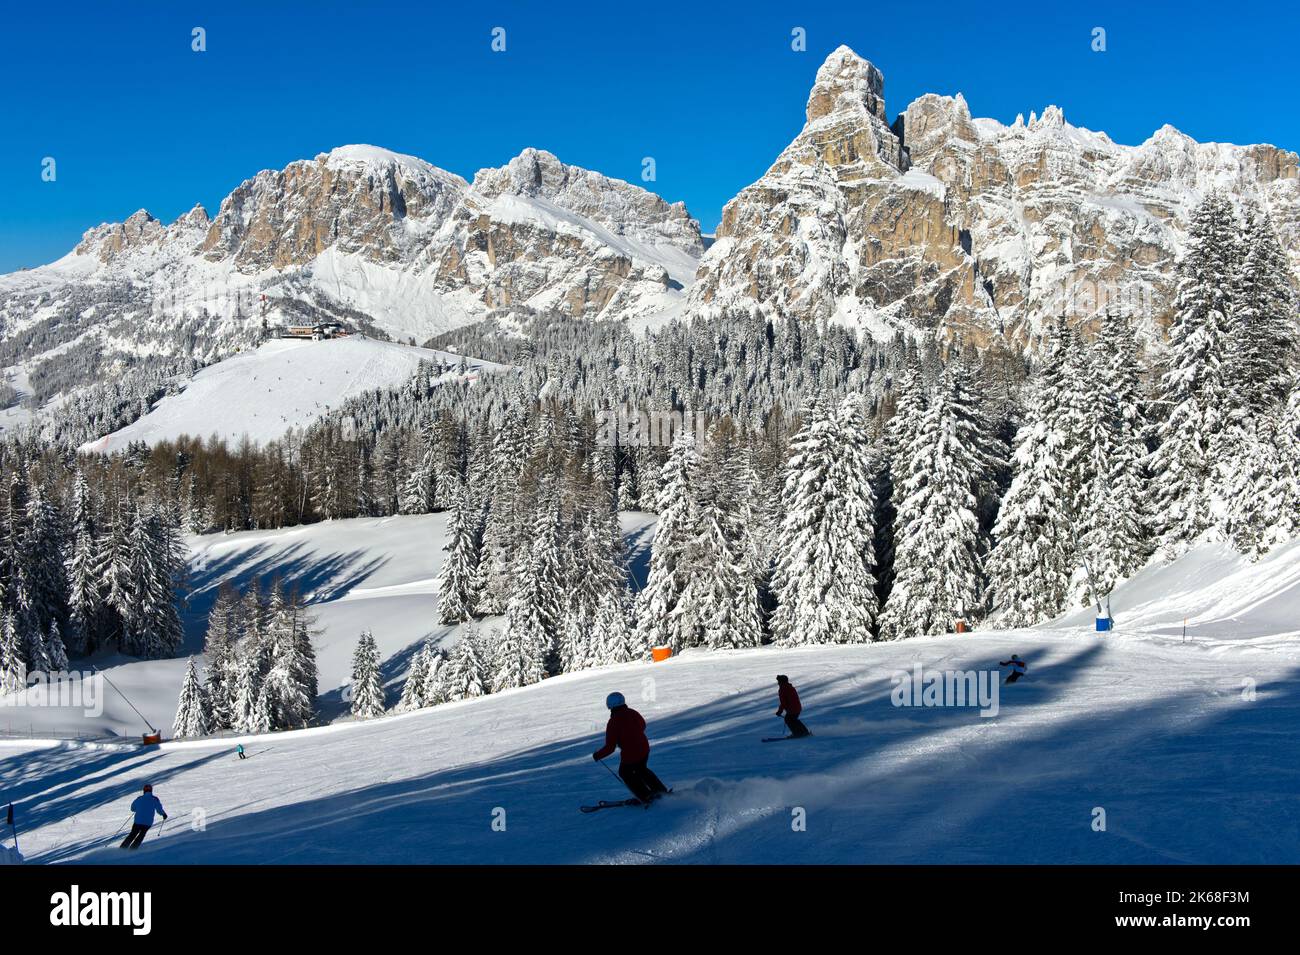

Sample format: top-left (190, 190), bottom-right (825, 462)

top-left (0, 47), bottom-right (1300, 407)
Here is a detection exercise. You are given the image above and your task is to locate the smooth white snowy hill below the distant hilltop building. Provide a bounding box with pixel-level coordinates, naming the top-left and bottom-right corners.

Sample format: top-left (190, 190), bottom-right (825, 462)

top-left (83, 337), bottom-right (502, 452)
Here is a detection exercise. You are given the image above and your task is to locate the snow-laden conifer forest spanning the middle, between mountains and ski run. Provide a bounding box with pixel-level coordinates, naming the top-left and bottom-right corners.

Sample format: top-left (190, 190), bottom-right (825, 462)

top-left (0, 187), bottom-right (1300, 734)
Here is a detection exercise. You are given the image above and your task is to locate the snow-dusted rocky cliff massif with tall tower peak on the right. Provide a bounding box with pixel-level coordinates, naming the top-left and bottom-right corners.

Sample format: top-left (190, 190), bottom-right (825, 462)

top-left (688, 47), bottom-right (1300, 344)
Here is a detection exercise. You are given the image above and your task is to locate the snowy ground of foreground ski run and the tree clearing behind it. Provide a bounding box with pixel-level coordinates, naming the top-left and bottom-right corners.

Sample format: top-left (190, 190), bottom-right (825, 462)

top-left (0, 515), bottom-right (1300, 863)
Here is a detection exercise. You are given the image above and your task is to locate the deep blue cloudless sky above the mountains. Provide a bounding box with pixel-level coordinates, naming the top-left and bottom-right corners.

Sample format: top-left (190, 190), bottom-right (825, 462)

top-left (0, 0), bottom-right (1300, 272)
